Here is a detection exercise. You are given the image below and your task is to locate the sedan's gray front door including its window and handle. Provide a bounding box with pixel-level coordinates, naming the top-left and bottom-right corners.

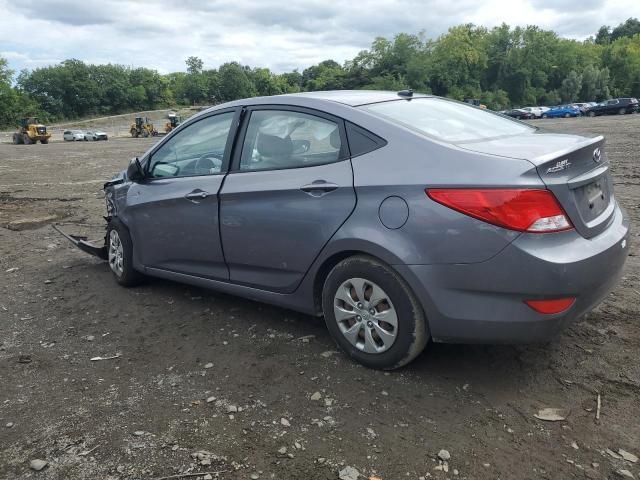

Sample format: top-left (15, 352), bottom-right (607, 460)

top-left (127, 111), bottom-right (235, 280)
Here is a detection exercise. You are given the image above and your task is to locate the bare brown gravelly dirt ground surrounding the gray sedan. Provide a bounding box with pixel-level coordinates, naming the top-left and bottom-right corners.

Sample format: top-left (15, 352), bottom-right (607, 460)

top-left (0, 115), bottom-right (640, 480)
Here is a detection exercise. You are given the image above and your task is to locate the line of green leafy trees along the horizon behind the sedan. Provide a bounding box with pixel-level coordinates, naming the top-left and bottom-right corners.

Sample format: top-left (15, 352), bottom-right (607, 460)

top-left (0, 18), bottom-right (640, 126)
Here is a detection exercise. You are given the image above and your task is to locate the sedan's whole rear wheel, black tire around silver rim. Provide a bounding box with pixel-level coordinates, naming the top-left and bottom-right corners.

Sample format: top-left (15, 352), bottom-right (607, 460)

top-left (322, 255), bottom-right (429, 370)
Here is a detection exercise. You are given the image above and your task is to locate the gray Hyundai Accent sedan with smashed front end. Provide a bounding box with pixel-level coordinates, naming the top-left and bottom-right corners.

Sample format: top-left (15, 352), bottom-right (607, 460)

top-left (60, 91), bottom-right (629, 369)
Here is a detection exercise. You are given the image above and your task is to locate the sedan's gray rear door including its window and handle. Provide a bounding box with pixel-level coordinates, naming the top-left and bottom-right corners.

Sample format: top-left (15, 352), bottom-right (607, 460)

top-left (220, 106), bottom-right (356, 293)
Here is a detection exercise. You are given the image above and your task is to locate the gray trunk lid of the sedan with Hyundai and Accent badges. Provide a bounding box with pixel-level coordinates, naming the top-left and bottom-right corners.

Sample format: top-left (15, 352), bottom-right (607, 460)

top-left (459, 133), bottom-right (615, 238)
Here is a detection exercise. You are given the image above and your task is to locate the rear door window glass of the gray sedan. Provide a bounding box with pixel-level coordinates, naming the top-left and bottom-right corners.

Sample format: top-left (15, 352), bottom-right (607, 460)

top-left (240, 110), bottom-right (342, 171)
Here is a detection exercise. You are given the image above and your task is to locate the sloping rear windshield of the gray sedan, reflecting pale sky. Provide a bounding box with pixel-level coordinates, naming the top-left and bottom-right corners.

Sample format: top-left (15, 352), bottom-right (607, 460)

top-left (361, 98), bottom-right (535, 143)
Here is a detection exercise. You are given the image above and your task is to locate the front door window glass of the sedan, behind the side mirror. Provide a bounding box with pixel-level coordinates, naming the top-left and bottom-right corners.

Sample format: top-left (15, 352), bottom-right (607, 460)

top-left (147, 112), bottom-right (234, 178)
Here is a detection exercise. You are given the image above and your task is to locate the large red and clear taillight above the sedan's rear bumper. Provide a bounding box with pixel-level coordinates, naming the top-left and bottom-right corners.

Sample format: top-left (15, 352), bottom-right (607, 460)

top-left (426, 188), bottom-right (573, 233)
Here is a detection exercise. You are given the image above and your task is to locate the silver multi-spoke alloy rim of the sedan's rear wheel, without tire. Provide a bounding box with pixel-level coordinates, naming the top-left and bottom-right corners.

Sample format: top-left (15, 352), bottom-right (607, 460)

top-left (333, 278), bottom-right (398, 353)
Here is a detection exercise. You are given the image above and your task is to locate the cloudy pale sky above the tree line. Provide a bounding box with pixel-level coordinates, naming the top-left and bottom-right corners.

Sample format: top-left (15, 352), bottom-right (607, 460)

top-left (0, 0), bottom-right (640, 73)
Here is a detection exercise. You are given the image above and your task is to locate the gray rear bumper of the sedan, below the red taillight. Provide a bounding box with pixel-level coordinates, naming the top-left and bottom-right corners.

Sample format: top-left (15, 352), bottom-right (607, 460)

top-left (395, 202), bottom-right (629, 343)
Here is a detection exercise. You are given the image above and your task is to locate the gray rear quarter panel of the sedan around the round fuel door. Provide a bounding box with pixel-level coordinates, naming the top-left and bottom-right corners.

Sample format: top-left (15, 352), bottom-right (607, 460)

top-left (332, 122), bottom-right (544, 265)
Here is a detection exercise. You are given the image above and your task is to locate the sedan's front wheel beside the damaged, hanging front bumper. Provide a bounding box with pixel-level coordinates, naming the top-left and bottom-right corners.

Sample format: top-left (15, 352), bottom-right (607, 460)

top-left (107, 218), bottom-right (143, 287)
